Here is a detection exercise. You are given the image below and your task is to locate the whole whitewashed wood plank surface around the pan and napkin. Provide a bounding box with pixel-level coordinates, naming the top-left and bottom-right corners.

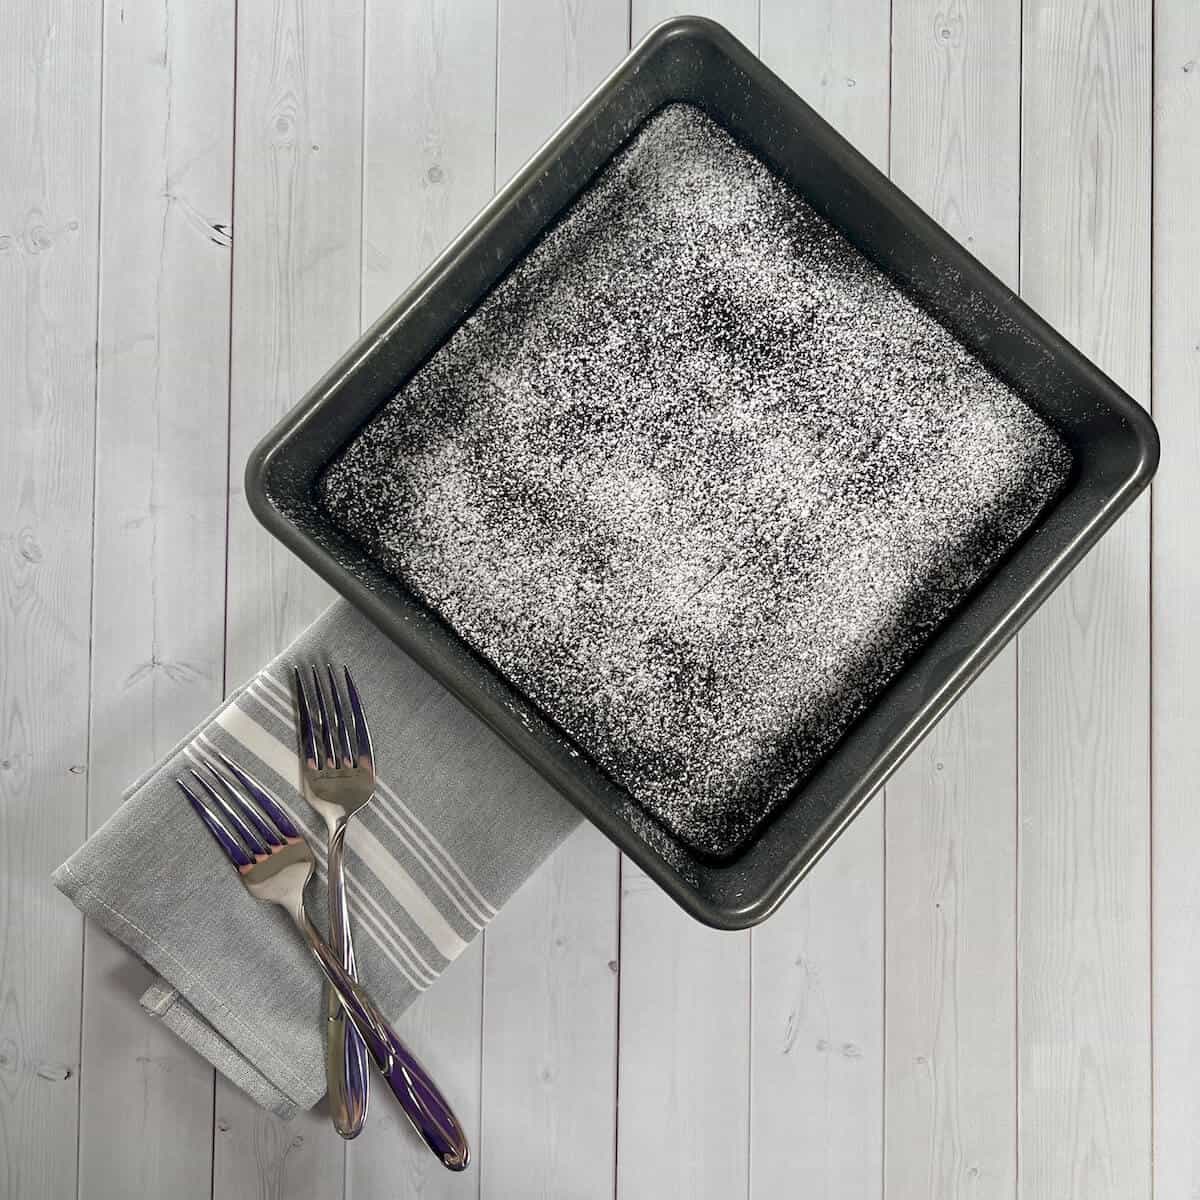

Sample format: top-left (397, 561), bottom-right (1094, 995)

top-left (0, 0), bottom-right (1200, 1200)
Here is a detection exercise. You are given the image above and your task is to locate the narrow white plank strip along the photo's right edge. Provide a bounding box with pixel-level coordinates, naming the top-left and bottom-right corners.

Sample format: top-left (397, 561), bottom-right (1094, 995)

top-left (1151, 0), bottom-right (1200, 1198)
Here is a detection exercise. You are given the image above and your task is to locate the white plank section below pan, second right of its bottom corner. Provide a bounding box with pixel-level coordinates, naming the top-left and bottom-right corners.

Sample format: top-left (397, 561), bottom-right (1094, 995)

top-left (884, 662), bottom-right (1016, 1200)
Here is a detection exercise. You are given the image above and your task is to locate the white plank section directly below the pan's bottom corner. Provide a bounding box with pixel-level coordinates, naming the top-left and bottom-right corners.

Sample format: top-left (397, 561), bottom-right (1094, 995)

top-left (617, 859), bottom-right (750, 1200)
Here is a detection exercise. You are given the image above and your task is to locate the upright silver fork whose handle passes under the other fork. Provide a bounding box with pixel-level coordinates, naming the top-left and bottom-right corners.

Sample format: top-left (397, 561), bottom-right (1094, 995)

top-left (293, 666), bottom-right (374, 1138)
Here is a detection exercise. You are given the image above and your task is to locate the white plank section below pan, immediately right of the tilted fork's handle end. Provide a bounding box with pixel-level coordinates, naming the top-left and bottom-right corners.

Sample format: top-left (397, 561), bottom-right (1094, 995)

top-left (479, 827), bottom-right (619, 1200)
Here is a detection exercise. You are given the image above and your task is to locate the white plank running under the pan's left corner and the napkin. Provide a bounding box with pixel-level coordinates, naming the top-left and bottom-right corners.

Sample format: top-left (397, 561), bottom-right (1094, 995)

top-left (214, 0), bottom-right (364, 1200)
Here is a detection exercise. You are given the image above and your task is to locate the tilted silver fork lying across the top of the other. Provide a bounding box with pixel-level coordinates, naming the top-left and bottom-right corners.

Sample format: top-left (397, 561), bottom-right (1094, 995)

top-left (175, 751), bottom-right (470, 1171)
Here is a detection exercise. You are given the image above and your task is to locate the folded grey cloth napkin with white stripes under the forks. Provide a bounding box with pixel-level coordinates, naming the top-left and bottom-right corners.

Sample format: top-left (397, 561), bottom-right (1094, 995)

top-left (54, 601), bottom-right (581, 1116)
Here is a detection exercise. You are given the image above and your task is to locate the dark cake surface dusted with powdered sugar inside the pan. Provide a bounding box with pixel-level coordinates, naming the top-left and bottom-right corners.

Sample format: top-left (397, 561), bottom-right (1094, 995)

top-left (322, 104), bottom-right (1070, 853)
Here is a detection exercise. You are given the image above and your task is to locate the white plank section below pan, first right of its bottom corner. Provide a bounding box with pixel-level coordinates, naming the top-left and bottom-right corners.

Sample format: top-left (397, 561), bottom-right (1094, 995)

top-left (750, 811), bottom-right (883, 1200)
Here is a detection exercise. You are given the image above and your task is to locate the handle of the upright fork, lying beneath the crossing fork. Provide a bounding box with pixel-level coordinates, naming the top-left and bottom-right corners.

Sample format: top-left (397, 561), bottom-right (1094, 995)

top-left (325, 821), bottom-right (371, 1138)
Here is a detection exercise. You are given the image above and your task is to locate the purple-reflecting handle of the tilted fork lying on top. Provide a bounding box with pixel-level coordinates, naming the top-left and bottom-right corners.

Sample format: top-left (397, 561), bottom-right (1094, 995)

top-left (293, 908), bottom-right (470, 1171)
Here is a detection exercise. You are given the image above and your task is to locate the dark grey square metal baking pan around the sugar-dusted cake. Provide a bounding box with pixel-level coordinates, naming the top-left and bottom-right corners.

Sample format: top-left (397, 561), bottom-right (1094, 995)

top-left (246, 17), bottom-right (1158, 929)
